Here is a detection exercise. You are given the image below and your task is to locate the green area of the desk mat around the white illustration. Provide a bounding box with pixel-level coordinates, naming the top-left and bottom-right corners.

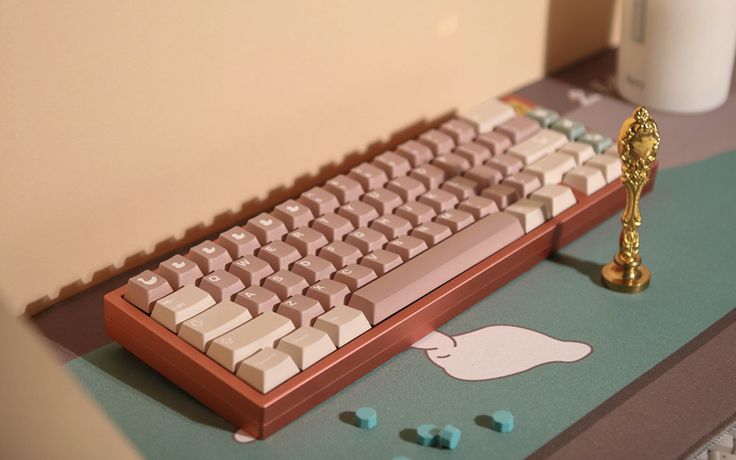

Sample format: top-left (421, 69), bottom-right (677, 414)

top-left (67, 151), bottom-right (736, 460)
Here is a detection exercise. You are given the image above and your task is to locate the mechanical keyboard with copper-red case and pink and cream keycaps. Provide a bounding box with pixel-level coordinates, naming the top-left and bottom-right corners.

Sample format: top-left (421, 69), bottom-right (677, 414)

top-left (105, 97), bottom-right (653, 438)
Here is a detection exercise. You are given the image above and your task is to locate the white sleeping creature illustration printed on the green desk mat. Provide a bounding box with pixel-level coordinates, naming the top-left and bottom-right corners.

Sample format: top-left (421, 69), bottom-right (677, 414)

top-left (412, 325), bottom-right (593, 380)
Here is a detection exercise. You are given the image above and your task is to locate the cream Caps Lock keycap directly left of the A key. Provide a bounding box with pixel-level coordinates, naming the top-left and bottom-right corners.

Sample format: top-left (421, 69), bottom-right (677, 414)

top-left (179, 300), bottom-right (252, 353)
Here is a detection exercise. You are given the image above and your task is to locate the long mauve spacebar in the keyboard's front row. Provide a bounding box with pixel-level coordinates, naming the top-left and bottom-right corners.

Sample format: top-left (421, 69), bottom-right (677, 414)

top-left (348, 212), bottom-right (524, 325)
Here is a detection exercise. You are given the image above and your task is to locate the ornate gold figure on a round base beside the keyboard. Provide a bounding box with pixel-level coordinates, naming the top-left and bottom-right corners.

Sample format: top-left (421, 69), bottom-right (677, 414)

top-left (601, 107), bottom-right (660, 293)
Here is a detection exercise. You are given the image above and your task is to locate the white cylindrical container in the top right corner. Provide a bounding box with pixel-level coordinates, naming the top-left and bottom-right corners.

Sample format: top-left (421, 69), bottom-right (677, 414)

top-left (617, 0), bottom-right (736, 113)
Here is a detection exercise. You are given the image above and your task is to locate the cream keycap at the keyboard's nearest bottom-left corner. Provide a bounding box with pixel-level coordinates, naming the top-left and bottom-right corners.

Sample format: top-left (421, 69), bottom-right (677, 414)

top-left (236, 348), bottom-right (299, 394)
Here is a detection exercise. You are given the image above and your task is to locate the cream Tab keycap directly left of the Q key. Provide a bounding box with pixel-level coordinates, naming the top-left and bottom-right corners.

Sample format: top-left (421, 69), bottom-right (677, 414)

top-left (151, 284), bottom-right (215, 332)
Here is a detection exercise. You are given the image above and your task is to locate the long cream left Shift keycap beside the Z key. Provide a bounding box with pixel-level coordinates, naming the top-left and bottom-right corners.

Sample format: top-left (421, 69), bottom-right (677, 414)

top-left (207, 311), bottom-right (295, 372)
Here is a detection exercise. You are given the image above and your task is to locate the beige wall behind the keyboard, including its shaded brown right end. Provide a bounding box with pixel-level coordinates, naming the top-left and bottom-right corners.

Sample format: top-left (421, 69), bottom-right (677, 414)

top-left (0, 0), bottom-right (615, 314)
